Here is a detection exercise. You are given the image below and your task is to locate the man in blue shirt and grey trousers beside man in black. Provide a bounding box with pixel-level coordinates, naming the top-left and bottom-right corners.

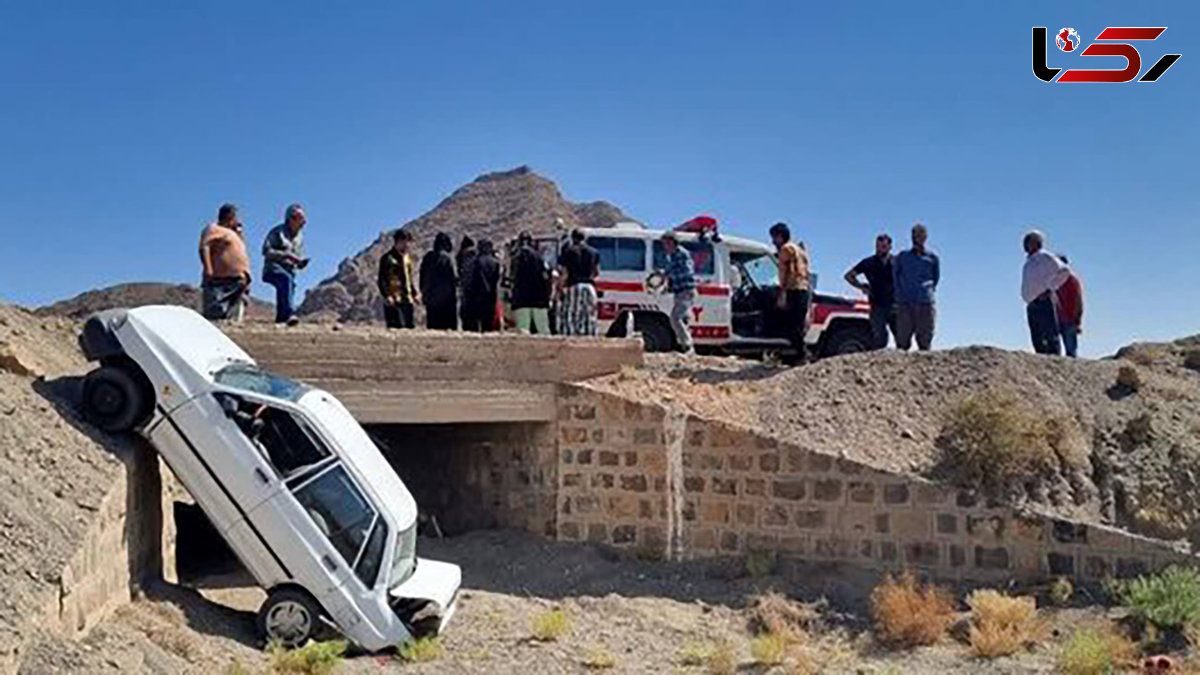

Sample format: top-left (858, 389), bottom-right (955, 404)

top-left (892, 222), bottom-right (941, 352)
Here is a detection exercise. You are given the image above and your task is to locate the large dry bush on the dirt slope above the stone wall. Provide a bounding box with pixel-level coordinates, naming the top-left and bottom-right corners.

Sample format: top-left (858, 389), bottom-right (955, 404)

top-left (937, 389), bottom-right (1085, 485)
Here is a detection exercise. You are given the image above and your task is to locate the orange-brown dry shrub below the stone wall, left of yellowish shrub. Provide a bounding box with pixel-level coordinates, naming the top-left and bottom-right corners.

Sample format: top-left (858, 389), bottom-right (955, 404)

top-left (871, 572), bottom-right (954, 649)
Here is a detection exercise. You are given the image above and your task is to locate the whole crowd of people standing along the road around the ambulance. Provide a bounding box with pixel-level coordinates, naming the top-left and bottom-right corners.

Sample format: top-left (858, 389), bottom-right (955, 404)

top-left (199, 199), bottom-right (1084, 359)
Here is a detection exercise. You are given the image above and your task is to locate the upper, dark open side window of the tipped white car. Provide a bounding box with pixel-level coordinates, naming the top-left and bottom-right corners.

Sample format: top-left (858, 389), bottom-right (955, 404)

top-left (217, 394), bottom-right (331, 478)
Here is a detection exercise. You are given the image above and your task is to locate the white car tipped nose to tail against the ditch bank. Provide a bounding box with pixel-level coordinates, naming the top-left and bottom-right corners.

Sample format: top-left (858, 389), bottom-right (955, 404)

top-left (79, 306), bottom-right (462, 651)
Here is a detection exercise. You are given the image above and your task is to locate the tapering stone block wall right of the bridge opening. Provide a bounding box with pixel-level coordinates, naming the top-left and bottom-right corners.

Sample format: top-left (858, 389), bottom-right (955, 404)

top-left (558, 386), bottom-right (1196, 581)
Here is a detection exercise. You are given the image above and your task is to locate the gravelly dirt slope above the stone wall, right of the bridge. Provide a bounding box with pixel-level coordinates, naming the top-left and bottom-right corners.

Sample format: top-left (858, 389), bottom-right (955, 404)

top-left (592, 339), bottom-right (1200, 538)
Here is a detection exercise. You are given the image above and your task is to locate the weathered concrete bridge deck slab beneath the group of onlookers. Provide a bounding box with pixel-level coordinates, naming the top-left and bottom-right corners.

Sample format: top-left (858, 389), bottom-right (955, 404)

top-left (226, 324), bottom-right (642, 424)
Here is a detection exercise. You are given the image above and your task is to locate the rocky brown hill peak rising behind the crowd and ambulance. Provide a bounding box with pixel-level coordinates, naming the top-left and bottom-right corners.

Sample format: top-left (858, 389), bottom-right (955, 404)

top-left (300, 167), bottom-right (631, 321)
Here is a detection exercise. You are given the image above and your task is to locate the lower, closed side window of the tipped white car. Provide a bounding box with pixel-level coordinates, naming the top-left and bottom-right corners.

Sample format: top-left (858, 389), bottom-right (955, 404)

top-left (295, 465), bottom-right (376, 566)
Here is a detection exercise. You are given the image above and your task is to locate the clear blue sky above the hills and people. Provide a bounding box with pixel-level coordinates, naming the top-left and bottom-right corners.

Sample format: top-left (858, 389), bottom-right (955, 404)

top-left (0, 0), bottom-right (1200, 356)
